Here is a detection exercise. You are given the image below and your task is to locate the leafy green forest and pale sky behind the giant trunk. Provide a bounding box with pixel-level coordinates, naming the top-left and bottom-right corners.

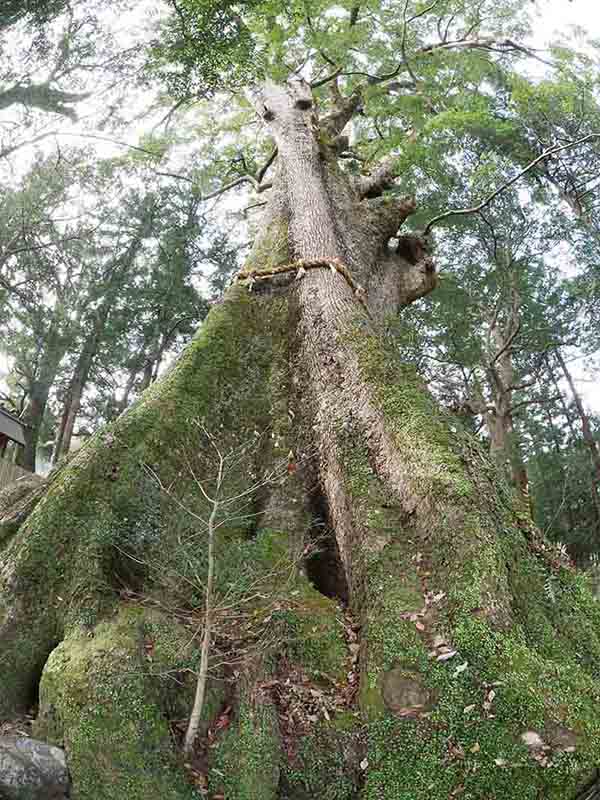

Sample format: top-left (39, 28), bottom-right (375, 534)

top-left (0, 0), bottom-right (600, 559)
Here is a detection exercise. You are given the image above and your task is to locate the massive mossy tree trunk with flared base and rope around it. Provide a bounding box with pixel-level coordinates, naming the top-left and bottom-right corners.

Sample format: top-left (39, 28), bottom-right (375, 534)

top-left (0, 79), bottom-right (600, 800)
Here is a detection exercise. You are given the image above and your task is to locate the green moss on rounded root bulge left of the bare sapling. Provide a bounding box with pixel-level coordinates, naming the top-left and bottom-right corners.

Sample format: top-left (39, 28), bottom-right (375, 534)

top-left (36, 606), bottom-right (196, 800)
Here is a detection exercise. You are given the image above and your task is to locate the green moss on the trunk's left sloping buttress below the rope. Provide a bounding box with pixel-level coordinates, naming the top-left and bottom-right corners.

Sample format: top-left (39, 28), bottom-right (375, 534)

top-left (0, 289), bottom-right (286, 714)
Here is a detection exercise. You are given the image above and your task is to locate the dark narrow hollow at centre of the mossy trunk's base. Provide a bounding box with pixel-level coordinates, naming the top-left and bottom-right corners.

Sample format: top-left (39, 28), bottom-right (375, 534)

top-left (304, 489), bottom-right (348, 604)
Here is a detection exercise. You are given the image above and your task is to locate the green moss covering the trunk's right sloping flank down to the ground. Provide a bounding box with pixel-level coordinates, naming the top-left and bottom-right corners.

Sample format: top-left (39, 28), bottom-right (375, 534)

top-left (347, 334), bottom-right (600, 800)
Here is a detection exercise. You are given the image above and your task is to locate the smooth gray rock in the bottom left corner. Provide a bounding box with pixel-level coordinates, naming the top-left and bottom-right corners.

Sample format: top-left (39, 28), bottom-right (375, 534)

top-left (0, 736), bottom-right (69, 800)
